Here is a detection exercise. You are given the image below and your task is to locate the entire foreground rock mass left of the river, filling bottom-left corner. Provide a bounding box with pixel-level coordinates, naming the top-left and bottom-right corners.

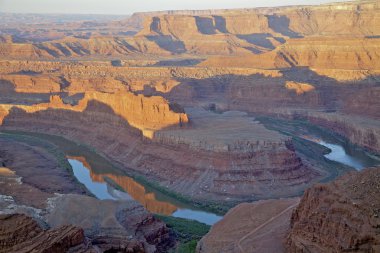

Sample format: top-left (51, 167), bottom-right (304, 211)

top-left (0, 134), bottom-right (174, 252)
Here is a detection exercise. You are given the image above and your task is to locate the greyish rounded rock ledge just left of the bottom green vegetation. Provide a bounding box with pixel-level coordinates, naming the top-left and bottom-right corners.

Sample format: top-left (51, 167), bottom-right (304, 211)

top-left (45, 194), bottom-right (174, 252)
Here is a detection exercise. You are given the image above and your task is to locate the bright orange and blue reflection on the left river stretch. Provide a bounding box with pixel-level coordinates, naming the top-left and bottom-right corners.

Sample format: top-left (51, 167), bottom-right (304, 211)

top-left (67, 156), bottom-right (222, 225)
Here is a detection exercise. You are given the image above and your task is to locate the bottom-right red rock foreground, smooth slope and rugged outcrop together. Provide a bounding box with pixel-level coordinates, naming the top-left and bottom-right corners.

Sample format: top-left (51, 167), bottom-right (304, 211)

top-left (197, 168), bottom-right (380, 253)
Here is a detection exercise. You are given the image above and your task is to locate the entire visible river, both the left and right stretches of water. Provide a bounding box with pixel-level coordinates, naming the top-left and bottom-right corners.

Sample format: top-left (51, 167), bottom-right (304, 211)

top-left (5, 128), bottom-right (380, 225)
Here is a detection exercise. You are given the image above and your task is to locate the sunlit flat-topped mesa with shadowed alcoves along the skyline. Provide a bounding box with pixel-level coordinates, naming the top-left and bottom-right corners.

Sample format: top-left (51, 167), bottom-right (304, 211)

top-left (140, 1), bottom-right (380, 38)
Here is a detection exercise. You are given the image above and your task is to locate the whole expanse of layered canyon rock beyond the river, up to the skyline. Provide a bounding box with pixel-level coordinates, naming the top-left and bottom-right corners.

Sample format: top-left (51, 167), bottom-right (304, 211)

top-left (0, 1), bottom-right (380, 210)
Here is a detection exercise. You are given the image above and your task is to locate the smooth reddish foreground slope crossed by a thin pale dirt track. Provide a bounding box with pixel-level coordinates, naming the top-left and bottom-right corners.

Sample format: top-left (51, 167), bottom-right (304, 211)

top-left (198, 198), bottom-right (299, 253)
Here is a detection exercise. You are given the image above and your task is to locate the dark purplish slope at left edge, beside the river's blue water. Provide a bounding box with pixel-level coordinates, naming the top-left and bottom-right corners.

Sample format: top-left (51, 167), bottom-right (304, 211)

top-left (0, 134), bottom-right (87, 211)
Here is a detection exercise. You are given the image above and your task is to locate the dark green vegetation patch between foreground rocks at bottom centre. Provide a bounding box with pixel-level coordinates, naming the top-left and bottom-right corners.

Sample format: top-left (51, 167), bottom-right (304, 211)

top-left (155, 215), bottom-right (210, 253)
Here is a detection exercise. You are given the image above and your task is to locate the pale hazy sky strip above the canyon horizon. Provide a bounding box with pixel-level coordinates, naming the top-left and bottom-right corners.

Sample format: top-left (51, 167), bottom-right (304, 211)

top-left (0, 0), bottom-right (350, 14)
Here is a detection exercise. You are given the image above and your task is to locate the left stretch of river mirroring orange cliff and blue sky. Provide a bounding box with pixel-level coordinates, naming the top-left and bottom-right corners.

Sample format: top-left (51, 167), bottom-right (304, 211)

top-left (0, 131), bottom-right (223, 225)
